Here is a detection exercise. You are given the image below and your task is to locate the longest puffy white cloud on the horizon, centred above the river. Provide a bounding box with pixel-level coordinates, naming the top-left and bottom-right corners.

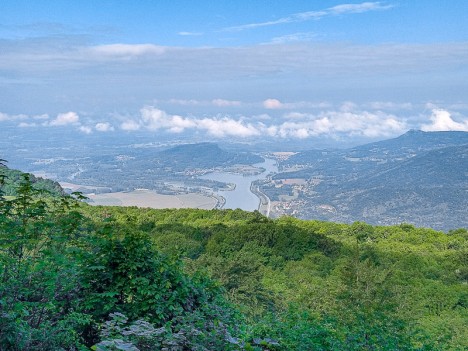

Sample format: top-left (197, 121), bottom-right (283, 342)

top-left (121, 106), bottom-right (408, 139)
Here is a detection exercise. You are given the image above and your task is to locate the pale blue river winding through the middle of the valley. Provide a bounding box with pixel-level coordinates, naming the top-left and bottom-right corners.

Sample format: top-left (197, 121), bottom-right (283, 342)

top-left (200, 158), bottom-right (278, 211)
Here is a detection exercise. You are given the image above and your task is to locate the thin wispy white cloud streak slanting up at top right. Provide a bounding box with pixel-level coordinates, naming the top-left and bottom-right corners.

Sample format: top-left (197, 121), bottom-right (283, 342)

top-left (224, 1), bottom-right (393, 31)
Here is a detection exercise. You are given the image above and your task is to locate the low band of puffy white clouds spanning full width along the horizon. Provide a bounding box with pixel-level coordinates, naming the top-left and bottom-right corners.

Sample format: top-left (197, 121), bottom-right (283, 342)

top-left (4, 106), bottom-right (468, 140)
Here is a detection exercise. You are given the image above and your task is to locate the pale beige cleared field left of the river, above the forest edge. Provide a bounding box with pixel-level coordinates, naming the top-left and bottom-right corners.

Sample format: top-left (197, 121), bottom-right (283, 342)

top-left (86, 190), bottom-right (217, 210)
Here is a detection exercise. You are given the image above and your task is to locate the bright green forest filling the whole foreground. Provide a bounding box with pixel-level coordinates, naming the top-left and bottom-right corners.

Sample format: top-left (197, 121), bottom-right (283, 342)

top-left (0, 166), bottom-right (468, 351)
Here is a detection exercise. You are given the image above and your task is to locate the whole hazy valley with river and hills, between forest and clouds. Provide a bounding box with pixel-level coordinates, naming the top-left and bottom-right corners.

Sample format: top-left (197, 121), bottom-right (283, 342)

top-left (2, 131), bottom-right (468, 231)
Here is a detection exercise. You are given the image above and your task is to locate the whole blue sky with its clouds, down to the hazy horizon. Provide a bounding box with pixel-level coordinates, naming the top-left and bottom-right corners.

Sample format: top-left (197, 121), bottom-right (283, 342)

top-left (0, 0), bottom-right (468, 143)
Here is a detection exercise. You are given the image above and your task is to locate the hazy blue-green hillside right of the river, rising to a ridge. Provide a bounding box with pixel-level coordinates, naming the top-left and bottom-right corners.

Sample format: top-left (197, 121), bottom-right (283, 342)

top-left (266, 131), bottom-right (468, 230)
